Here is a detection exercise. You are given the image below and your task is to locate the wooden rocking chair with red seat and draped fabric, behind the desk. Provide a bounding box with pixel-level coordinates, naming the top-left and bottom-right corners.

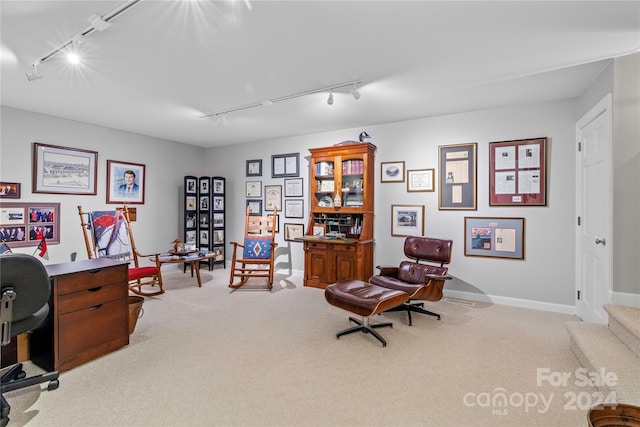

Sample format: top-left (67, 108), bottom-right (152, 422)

top-left (78, 206), bottom-right (164, 296)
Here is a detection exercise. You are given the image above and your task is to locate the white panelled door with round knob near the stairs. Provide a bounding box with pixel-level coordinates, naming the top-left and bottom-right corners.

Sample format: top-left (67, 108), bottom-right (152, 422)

top-left (576, 94), bottom-right (613, 324)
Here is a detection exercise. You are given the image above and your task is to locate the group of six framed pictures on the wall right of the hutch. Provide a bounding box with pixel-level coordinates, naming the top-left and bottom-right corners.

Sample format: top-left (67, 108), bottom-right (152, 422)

top-left (380, 138), bottom-right (547, 259)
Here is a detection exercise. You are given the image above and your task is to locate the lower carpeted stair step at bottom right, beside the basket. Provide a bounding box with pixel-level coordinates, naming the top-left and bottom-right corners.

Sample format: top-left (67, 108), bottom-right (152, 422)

top-left (565, 322), bottom-right (640, 405)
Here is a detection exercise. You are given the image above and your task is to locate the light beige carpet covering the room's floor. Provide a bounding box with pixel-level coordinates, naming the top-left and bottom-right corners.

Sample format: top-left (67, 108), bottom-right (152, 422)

top-left (7, 269), bottom-right (595, 427)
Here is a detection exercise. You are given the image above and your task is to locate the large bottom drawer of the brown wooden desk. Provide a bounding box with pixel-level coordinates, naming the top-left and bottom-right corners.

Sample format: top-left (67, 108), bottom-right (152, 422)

top-left (58, 299), bottom-right (129, 369)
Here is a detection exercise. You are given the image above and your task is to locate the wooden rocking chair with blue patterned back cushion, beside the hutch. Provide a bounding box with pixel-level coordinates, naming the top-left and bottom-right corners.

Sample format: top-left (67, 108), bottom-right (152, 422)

top-left (229, 206), bottom-right (277, 289)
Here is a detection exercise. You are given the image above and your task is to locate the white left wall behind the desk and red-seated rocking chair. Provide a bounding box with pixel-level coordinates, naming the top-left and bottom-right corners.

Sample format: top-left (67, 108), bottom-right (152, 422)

top-left (0, 107), bottom-right (204, 264)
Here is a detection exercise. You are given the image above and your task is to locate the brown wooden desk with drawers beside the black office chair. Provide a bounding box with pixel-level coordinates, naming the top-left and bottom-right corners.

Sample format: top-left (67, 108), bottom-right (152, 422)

top-left (29, 258), bottom-right (129, 371)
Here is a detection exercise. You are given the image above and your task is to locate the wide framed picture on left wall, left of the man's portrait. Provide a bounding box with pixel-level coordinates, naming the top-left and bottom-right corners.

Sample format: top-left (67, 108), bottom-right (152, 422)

top-left (32, 142), bottom-right (98, 196)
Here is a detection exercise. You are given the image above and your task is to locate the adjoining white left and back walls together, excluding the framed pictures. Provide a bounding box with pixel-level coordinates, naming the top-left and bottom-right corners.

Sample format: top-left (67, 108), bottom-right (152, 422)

top-left (0, 93), bottom-right (628, 312)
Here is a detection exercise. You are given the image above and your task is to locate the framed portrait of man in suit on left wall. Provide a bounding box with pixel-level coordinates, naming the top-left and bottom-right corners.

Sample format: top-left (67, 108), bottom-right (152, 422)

top-left (107, 160), bottom-right (145, 205)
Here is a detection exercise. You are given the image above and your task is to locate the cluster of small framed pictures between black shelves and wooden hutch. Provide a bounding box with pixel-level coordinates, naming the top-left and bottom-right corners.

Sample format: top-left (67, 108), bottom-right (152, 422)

top-left (245, 153), bottom-right (304, 240)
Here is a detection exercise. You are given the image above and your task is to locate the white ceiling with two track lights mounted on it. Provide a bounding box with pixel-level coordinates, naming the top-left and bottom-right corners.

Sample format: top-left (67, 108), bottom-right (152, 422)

top-left (0, 0), bottom-right (640, 147)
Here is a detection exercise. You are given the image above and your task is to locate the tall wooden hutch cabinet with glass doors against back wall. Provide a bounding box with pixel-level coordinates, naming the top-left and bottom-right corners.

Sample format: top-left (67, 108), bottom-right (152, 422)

top-left (300, 142), bottom-right (376, 288)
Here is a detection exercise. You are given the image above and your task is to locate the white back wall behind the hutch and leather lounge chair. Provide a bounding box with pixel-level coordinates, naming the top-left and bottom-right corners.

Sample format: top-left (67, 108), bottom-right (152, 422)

top-left (207, 101), bottom-right (576, 311)
